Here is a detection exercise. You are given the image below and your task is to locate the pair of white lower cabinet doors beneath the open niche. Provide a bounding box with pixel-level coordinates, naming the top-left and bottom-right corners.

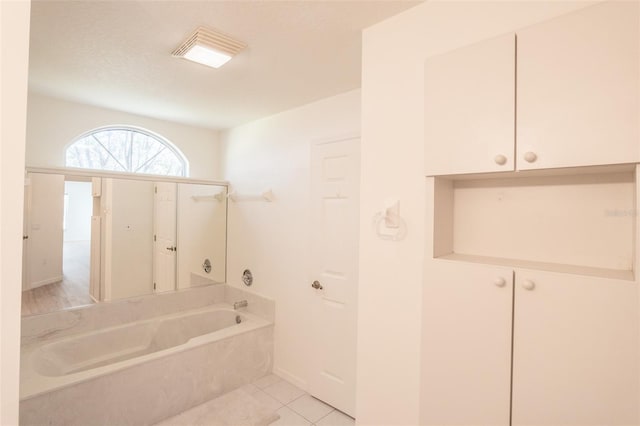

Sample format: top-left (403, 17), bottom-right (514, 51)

top-left (423, 260), bottom-right (638, 426)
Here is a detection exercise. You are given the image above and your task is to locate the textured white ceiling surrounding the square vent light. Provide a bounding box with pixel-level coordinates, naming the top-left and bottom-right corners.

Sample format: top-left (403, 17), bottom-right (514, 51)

top-left (29, 0), bottom-right (419, 129)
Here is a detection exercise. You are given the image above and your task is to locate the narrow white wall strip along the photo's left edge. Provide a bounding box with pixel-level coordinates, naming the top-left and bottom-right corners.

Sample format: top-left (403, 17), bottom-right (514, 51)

top-left (0, 0), bottom-right (30, 426)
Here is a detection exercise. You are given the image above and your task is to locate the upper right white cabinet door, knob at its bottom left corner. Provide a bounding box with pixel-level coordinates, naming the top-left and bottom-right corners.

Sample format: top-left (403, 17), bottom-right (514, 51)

top-left (516, 1), bottom-right (640, 170)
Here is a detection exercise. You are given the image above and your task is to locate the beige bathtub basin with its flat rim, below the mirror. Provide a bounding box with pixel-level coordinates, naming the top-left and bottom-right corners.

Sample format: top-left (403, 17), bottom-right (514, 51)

top-left (20, 303), bottom-right (272, 399)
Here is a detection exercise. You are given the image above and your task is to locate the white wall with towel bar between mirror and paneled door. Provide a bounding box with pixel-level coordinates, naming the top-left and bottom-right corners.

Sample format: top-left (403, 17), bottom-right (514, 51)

top-left (222, 90), bottom-right (360, 387)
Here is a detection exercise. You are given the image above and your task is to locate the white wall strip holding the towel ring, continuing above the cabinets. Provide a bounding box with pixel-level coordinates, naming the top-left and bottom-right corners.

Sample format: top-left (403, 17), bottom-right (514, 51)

top-left (356, 1), bottom-right (600, 425)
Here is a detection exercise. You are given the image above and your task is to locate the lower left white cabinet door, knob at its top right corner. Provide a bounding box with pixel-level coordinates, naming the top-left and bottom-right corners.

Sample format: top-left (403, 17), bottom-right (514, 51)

top-left (421, 260), bottom-right (513, 426)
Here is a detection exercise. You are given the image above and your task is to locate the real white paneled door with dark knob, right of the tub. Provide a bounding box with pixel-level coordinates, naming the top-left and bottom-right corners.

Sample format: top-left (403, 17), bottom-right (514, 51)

top-left (308, 138), bottom-right (360, 416)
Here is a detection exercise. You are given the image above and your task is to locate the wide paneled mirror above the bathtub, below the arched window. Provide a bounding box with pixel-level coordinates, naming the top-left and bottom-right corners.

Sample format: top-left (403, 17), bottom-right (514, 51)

top-left (23, 173), bottom-right (227, 315)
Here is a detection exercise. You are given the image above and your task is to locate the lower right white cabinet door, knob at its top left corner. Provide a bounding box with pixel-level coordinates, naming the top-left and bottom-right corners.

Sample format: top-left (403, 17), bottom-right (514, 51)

top-left (513, 270), bottom-right (638, 426)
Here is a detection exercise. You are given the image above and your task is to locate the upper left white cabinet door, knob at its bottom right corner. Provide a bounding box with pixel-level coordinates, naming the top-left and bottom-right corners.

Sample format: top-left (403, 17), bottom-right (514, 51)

top-left (425, 34), bottom-right (515, 176)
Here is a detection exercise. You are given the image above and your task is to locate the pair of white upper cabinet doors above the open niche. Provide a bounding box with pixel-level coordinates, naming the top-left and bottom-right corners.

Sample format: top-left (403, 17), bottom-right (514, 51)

top-left (425, 1), bottom-right (640, 176)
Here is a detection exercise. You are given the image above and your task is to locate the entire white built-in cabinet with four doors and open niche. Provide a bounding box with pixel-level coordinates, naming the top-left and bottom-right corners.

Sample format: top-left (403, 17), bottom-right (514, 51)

top-left (422, 1), bottom-right (640, 426)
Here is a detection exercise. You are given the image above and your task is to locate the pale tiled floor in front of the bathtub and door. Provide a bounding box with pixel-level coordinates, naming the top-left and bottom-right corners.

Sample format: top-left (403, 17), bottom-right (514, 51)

top-left (154, 374), bottom-right (355, 426)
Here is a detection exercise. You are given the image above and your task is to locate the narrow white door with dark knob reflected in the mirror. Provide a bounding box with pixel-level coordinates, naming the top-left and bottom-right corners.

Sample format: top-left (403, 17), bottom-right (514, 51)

top-left (153, 182), bottom-right (177, 292)
